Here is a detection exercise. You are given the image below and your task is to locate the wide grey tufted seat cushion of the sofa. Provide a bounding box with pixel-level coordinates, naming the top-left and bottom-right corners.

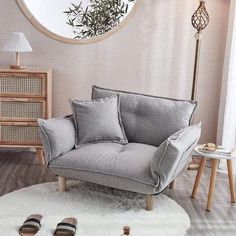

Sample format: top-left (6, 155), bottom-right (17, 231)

top-left (49, 143), bottom-right (157, 186)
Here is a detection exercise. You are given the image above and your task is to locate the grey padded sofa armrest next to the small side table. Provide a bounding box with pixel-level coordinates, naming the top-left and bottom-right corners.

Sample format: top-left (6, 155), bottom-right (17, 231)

top-left (151, 123), bottom-right (201, 192)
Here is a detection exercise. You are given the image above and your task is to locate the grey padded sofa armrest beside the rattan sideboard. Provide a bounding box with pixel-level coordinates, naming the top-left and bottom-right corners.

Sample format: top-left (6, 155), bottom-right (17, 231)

top-left (38, 116), bottom-right (75, 164)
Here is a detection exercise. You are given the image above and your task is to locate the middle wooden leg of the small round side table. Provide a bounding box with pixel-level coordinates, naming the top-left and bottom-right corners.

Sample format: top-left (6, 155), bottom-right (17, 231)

top-left (206, 159), bottom-right (219, 211)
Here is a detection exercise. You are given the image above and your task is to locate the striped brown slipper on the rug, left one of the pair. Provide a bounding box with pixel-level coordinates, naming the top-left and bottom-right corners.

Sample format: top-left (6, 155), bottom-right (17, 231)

top-left (19, 214), bottom-right (43, 236)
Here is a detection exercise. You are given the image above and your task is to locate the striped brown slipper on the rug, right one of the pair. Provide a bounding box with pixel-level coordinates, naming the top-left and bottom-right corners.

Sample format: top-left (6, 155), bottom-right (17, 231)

top-left (54, 217), bottom-right (77, 236)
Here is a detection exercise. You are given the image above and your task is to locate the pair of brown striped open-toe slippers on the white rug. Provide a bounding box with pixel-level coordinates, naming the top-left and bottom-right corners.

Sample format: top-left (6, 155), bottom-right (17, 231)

top-left (19, 215), bottom-right (77, 236)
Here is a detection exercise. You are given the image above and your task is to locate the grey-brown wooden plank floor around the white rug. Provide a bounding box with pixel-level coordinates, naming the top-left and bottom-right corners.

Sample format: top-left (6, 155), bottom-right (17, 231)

top-left (0, 151), bottom-right (236, 236)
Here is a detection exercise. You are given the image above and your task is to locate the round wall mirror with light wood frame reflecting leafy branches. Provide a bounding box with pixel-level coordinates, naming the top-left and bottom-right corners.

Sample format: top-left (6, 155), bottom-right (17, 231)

top-left (17, 0), bottom-right (139, 44)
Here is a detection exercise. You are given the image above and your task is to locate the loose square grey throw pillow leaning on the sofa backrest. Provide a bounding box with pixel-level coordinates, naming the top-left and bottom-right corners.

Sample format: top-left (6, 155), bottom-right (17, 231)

top-left (70, 95), bottom-right (128, 148)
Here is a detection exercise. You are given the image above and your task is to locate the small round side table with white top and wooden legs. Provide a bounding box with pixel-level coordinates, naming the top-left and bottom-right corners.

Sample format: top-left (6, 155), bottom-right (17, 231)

top-left (192, 147), bottom-right (236, 211)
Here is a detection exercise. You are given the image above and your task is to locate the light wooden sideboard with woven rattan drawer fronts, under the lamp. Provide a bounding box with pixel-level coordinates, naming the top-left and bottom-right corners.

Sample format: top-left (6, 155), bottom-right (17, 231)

top-left (0, 68), bottom-right (52, 164)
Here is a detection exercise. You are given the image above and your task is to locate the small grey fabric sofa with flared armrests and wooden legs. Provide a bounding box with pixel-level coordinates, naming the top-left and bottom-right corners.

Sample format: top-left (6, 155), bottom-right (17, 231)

top-left (38, 86), bottom-right (201, 210)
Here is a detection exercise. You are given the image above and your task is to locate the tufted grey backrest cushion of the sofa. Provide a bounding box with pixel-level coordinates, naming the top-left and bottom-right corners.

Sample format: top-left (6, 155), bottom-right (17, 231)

top-left (92, 86), bottom-right (197, 146)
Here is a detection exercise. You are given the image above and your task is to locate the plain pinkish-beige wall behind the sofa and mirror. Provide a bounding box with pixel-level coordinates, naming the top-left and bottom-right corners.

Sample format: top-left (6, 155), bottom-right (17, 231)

top-left (0, 0), bottom-right (230, 142)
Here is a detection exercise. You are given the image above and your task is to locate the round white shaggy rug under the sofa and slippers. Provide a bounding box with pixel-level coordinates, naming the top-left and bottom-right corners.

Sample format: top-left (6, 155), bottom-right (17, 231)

top-left (0, 181), bottom-right (190, 236)
